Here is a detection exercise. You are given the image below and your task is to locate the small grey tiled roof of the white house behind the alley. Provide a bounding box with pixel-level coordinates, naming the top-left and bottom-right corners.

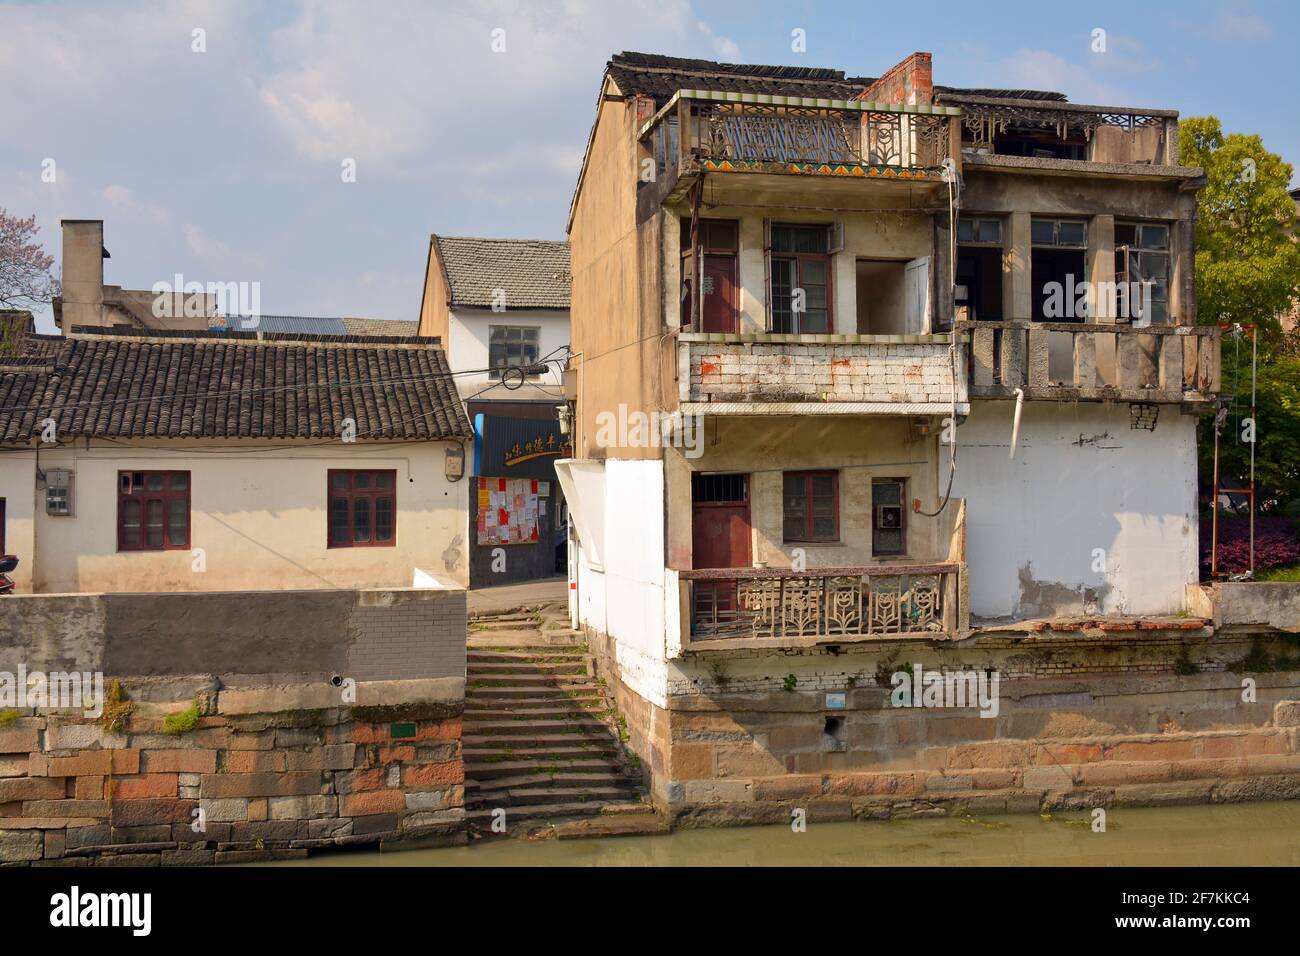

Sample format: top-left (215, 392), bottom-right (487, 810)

top-left (433, 235), bottom-right (569, 310)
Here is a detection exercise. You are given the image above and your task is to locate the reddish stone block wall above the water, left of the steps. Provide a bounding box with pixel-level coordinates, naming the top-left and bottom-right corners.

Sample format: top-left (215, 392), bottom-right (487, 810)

top-left (0, 679), bottom-right (464, 866)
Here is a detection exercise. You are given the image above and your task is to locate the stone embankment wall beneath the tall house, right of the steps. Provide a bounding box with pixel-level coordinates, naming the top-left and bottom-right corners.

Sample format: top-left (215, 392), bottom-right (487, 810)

top-left (590, 630), bottom-right (1300, 826)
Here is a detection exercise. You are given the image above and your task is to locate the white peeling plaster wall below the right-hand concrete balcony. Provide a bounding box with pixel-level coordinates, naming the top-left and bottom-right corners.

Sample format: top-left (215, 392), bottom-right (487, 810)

top-left (941, 402), bottom-right (1197, 619)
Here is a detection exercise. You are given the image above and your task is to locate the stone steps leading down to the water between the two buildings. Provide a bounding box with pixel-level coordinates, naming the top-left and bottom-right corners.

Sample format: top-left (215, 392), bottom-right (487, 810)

top-left (462, 605), bottom-right (649, 835)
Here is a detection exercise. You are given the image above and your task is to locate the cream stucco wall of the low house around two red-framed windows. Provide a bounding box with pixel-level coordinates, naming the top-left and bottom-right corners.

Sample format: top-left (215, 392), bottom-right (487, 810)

top-left (19, 440), bottom-right (468, 592)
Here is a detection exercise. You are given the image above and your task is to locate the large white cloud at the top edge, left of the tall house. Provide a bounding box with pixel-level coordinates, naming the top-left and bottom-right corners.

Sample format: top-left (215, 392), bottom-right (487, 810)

top-left (257, 0), bottom-right (702, 172)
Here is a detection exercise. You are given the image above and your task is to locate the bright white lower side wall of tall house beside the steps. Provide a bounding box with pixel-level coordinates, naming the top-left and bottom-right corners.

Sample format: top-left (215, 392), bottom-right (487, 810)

top-left (577, 460), bottom-right (676, 708)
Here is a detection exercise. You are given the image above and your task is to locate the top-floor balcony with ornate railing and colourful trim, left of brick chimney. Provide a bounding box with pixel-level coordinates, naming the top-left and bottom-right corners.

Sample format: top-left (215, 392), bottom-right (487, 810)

top-left (641, 90), bottom-right (961, 212)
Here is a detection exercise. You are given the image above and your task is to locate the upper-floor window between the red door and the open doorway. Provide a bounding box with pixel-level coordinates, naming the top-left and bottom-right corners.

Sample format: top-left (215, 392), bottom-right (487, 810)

top-left (770, 224), bottom-right (833, 334)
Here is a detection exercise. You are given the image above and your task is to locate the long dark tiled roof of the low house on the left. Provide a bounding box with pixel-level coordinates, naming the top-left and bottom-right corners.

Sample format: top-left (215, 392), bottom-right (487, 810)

top-left (0, 328), bottom-right (472, 442)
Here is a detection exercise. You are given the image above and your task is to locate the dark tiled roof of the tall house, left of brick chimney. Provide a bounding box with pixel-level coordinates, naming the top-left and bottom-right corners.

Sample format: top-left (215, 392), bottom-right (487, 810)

top-left (606, 52), bottom-right (874, 101)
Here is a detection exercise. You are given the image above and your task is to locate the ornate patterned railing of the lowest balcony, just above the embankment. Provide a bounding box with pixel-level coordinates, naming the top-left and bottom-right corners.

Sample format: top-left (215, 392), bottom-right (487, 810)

top-left (679, 562), bottom-right (961, 641)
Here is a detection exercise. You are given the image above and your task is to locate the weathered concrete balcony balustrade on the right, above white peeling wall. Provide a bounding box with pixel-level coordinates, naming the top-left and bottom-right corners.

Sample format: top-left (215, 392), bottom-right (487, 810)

top-left (958, 321), bottom-right (1219, 403)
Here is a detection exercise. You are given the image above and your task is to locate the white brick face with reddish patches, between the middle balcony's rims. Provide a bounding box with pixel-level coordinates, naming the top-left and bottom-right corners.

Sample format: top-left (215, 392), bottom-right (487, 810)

top-left (688, 342), bottom-right (966, 405)
